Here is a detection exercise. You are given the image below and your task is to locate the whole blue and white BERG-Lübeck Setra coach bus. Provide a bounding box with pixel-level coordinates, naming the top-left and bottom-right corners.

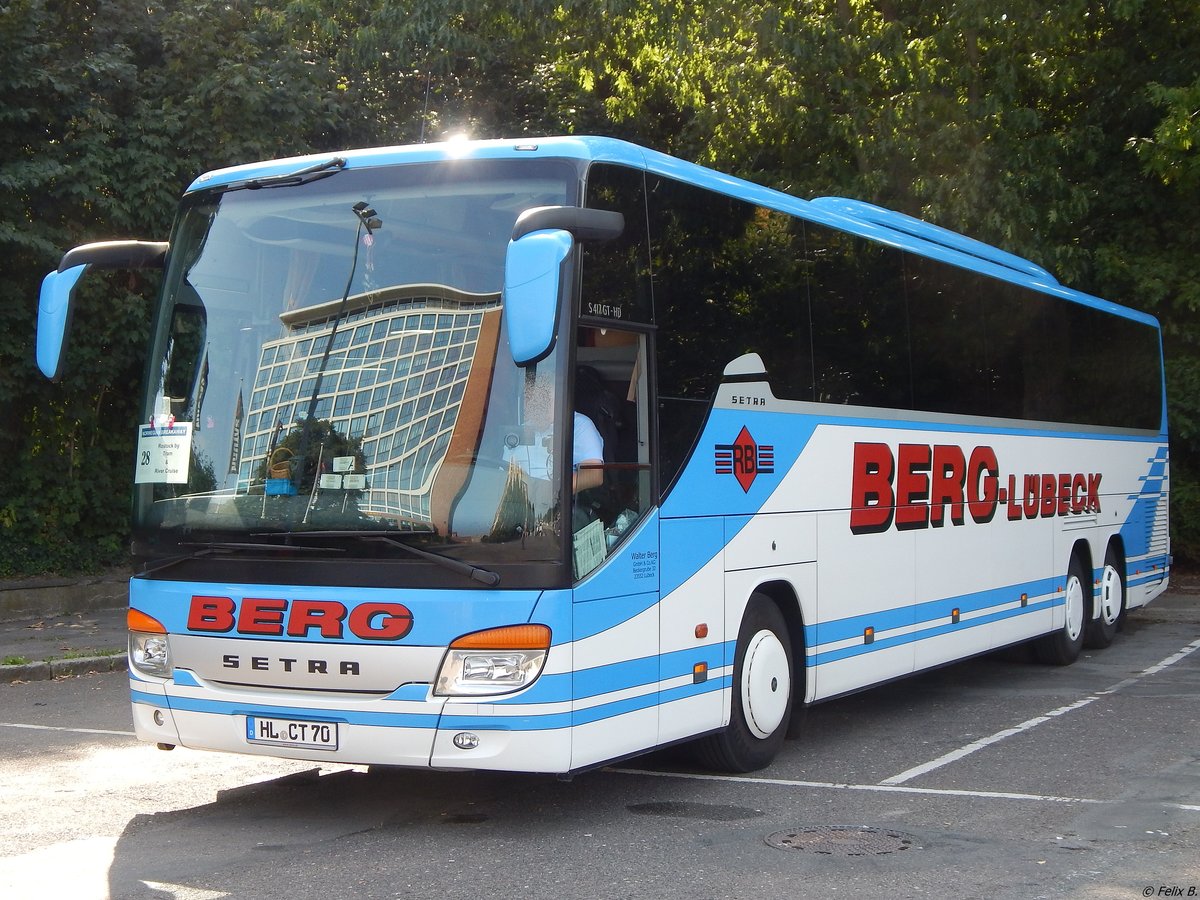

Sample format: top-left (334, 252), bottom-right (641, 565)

top-left (37, 138), bottom-right (1170, 774)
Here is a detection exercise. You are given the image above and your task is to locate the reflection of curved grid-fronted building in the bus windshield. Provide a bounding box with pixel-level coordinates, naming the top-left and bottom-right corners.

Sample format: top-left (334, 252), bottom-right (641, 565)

top-left (238, 284), bottom-right (500, 533)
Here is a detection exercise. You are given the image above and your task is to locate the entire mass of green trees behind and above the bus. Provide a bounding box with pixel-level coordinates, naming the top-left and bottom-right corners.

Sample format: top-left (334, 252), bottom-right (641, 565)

top-left (0, 0), bottom-right (1200, 576)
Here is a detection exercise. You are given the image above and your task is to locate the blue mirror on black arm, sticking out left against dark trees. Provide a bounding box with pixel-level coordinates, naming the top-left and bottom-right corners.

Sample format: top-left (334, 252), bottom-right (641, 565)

top-left (37, 241), bottom-right (168, 382)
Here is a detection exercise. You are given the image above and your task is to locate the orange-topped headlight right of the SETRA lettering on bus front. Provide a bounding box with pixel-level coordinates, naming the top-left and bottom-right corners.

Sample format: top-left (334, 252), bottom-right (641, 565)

top-left (433, 625), bottom-right (550, 697)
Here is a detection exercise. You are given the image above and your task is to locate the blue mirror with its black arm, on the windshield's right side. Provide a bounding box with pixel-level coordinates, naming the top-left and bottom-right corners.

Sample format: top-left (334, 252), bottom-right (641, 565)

top-left (504, 206), bottom-right (625, 367)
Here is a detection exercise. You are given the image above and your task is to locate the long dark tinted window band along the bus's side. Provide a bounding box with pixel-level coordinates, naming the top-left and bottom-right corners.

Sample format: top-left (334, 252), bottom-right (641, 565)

top-left (583, 166), bottom-right (1162, 508)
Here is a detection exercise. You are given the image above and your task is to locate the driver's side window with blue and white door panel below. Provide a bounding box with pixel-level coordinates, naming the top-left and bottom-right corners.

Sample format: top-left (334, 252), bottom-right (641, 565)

top-left (570, 326), bottom-right (661, 768)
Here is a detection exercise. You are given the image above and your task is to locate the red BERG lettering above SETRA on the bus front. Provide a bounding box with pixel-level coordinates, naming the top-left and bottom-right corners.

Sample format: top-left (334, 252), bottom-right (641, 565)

top-left (187, 595), bottom-right (413, 641)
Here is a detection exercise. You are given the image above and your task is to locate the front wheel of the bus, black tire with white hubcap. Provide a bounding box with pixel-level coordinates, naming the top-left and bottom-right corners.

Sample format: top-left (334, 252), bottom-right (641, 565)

top-left (696, 594), bottom-right (794, 772)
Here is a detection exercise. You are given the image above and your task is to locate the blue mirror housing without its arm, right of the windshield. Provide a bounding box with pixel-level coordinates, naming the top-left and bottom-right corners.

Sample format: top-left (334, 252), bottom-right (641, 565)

top-left (504, 229), bottom-right (575, 368)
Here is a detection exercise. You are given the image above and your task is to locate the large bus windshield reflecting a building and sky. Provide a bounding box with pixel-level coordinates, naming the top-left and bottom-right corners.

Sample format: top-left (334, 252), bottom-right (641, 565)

top-left (134, 160), bottom-right (577, 565)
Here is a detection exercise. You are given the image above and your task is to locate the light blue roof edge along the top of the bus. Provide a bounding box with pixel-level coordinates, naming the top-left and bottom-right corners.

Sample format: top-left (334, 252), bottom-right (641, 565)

top-left (187, 137), bottom-right (1158, 328)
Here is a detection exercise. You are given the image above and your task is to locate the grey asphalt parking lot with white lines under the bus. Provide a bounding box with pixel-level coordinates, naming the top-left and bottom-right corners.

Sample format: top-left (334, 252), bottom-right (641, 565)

top-left (0, 583), bottom-right (1200, 900)
